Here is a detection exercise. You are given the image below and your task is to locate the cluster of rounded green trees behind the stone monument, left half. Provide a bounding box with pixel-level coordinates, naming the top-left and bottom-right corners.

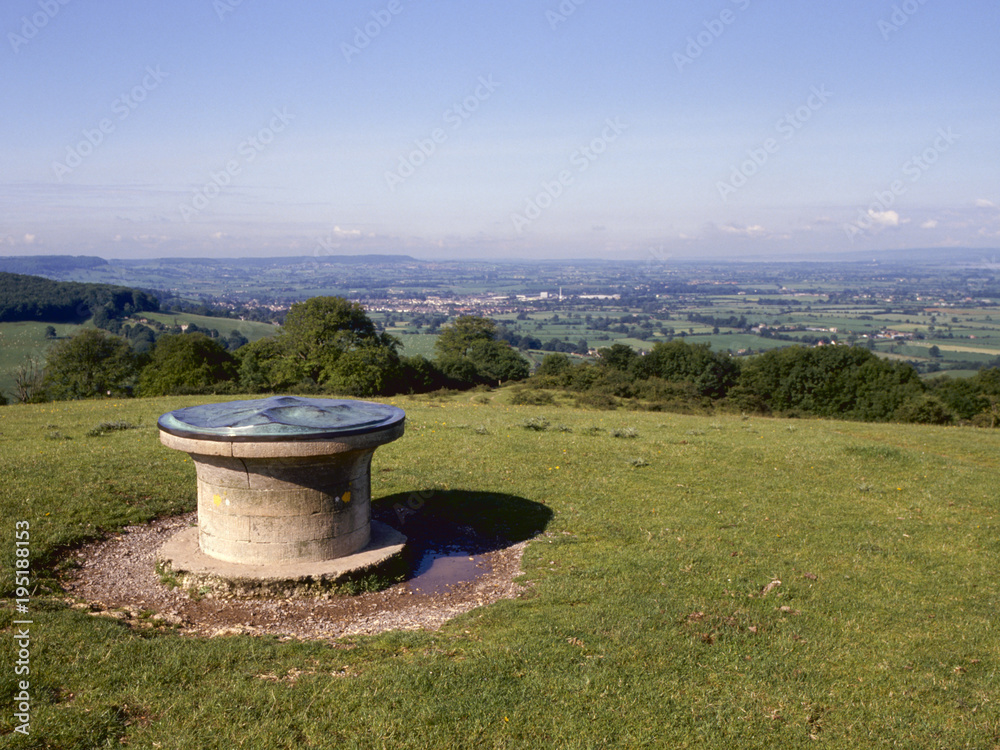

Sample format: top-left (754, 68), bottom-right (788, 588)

top-left (5, 297), bottom-right (530, 401)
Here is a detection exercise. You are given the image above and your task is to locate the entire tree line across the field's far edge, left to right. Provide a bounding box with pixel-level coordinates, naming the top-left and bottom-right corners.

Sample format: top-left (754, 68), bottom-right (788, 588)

top-left (0, 297), bottom-right (1000, 427)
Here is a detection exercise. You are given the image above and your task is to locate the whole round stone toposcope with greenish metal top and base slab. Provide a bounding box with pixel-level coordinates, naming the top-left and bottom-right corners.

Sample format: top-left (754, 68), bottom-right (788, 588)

top-left (157, 396), bottom-right (406, 594)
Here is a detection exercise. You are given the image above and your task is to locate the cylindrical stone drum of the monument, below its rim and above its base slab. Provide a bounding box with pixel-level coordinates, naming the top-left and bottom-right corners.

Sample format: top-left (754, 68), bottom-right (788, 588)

top-left (192, 449), bottom-right (374, 565)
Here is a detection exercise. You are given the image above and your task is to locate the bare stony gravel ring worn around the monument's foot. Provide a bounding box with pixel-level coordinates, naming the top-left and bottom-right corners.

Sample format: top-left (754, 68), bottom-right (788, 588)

top-left (64, 513), bottom-right (527, 640)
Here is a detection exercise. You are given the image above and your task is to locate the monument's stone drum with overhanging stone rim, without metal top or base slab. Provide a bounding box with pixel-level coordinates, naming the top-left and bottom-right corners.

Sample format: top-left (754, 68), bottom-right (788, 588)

top-left (160, 412), bottom-right (404, 567)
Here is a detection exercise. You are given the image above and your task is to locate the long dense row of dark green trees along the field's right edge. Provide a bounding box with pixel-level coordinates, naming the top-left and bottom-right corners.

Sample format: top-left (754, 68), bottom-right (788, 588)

top-left (516, 340), bottom-right (1000, 427)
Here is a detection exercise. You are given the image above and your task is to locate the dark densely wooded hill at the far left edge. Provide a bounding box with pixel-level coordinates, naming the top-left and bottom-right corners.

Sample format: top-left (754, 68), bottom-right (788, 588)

top-left (0, 271), bottom-right (160, 323)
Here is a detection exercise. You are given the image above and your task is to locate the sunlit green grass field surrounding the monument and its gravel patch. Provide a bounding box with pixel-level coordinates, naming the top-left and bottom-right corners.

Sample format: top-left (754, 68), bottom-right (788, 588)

top-left (0, 393), bottom-right (1000, 750)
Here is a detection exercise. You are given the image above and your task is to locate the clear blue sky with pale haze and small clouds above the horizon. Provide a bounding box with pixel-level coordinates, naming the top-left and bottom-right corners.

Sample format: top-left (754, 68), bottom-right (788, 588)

top-left (0, 0), bottom-right (1000, 260)
